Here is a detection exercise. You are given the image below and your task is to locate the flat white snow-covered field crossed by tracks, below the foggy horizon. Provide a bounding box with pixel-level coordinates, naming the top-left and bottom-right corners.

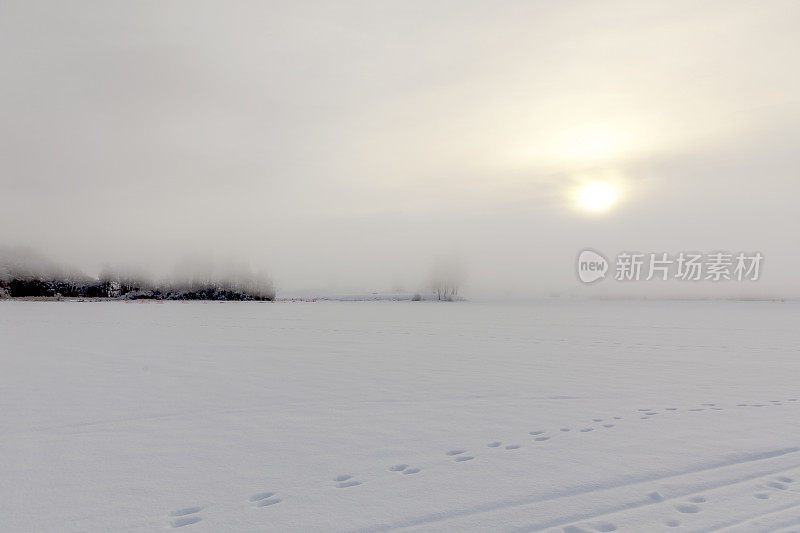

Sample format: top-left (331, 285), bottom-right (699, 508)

top-left (0, 300), bottom-right (800, 533)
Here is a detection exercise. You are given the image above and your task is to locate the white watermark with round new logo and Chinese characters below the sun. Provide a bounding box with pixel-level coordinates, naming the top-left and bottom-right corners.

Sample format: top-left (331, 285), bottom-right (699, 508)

top-left (578, 248), bottom-right (764, 284)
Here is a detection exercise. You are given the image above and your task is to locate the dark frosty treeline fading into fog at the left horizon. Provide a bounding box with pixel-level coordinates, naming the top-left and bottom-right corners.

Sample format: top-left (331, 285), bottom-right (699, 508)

top-left (0, 249), bottom-right (275, 301)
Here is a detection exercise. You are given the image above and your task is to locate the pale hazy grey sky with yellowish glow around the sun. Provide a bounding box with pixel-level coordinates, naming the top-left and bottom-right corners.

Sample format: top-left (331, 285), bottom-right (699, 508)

top-left (0, 0), bottom-right (800, 296)
